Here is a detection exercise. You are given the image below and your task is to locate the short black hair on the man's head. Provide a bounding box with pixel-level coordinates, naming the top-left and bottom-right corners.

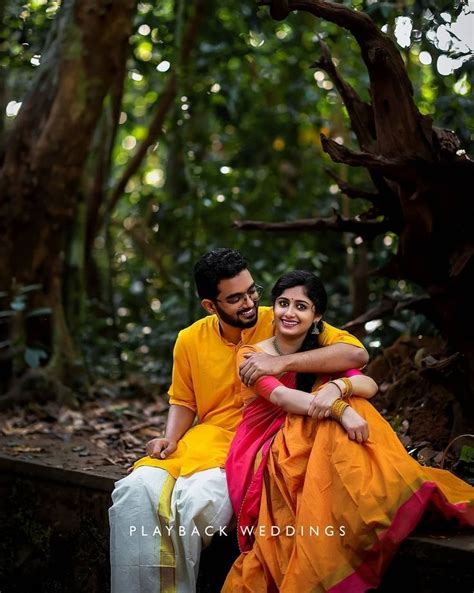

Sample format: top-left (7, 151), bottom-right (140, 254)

top-left (194, 247), bottom-right (247, 301)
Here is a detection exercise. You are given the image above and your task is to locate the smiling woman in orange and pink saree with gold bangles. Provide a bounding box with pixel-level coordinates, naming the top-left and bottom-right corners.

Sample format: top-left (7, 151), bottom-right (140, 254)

top-left (223, 271), bottom-right (474, 593)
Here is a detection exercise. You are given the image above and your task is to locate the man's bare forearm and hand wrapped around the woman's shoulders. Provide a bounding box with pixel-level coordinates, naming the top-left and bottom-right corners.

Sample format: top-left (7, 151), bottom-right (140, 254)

top-left (239, 344), bottom-right (369, 385)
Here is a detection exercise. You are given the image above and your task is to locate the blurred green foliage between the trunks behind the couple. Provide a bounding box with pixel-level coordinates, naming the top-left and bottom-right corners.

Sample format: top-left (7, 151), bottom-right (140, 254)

top-left (0, 0), bottom-right (474, 383)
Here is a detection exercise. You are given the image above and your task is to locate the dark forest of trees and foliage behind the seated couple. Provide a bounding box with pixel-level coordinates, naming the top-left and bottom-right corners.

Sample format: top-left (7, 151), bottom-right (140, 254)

top-left (0, 0), bottom-right (474, 468)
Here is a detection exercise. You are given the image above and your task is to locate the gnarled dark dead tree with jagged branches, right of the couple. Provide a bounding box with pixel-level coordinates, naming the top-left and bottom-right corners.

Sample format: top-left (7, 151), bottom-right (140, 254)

top-left (237, 0), bottom-right (474, 421)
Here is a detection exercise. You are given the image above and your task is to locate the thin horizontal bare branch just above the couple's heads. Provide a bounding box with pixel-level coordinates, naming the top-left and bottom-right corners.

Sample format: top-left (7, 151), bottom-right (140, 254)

top-left (233, 215), bottom-right (389, 239)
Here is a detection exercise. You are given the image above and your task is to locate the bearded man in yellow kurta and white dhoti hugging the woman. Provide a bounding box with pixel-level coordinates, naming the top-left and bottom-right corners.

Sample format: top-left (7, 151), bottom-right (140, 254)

top-left (109, 249), bottom-right (367, 593)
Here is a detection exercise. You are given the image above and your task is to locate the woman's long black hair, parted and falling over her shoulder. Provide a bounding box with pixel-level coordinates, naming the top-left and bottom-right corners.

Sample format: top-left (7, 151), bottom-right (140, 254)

top-left (272, 270), bottom-right (328, 393)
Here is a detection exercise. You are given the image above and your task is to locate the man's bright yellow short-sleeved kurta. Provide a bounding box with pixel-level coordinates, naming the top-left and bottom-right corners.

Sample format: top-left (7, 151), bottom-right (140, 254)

top-left (134, 307), bottom-right (363, 478)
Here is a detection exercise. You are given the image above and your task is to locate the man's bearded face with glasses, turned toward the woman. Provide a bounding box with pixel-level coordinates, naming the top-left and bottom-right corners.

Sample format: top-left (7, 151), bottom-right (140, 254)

top-left (214, 270), bottom-right (258, 329)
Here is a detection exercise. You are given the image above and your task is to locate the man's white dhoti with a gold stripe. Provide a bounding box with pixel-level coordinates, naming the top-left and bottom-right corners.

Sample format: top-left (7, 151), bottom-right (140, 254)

top-left (109, 466), bottom-right (232, 593)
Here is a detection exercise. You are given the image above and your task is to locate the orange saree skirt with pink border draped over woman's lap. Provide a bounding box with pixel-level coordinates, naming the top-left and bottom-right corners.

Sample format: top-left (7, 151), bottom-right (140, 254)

top-left (223, 364), bottom-right (474, 593)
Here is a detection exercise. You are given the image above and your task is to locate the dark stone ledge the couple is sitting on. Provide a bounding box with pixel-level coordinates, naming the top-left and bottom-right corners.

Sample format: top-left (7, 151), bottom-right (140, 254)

top-left (0, 454), bottom-right (474, 593)
